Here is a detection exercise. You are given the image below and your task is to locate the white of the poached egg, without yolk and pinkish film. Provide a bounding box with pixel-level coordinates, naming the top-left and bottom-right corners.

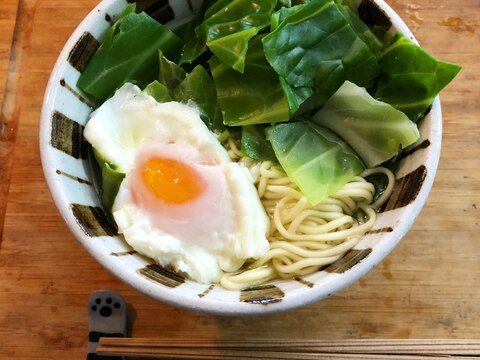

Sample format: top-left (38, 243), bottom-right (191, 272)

top-left (84, 84), bottom-right (269, 283)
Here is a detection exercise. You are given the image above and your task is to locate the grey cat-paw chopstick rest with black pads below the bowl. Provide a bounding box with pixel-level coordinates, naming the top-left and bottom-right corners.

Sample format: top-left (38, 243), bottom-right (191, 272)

top-left (87, 290), bottom-right (128, 360)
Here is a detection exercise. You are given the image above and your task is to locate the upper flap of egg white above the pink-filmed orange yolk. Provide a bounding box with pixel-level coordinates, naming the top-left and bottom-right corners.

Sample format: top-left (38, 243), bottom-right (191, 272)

top-left (84, 83), bottom-right (230, 173)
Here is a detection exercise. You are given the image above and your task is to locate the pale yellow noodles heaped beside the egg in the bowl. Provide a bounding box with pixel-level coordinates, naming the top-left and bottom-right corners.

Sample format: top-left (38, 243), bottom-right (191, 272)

top-left (220, 139), bottom-right (395, 290)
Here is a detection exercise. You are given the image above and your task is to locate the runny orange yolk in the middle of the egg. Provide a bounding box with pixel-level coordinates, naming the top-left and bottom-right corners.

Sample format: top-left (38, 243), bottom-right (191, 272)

top-left (142, 158), bottom-right (205, 204)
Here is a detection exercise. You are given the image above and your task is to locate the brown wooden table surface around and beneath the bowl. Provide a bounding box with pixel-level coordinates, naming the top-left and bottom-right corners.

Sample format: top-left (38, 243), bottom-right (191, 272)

top-left (0, 0), bottom-right (480, 359)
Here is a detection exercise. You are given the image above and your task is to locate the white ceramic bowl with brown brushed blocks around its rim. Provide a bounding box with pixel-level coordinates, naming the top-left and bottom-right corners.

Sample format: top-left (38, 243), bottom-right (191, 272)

top-left (40, 0), bottom-right (442, 315)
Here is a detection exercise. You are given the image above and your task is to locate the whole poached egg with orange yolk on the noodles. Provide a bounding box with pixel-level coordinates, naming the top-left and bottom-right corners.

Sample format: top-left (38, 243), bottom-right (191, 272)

top-left (84, 83), bottom-right (269, 283)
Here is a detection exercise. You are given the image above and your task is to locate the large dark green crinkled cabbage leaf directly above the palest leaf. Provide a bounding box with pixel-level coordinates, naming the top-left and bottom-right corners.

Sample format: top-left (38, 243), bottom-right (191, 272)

top-left (263, 0), bottom-right (381, 113)
